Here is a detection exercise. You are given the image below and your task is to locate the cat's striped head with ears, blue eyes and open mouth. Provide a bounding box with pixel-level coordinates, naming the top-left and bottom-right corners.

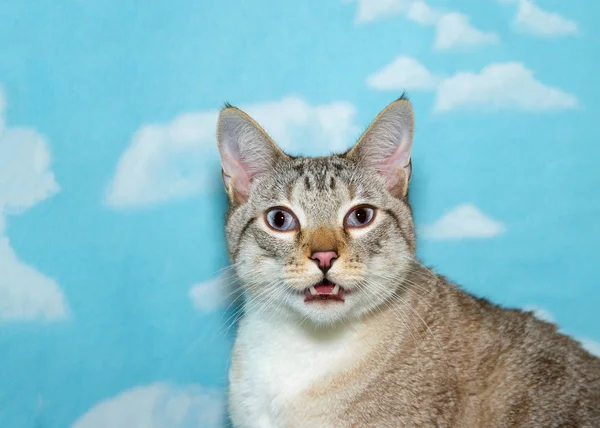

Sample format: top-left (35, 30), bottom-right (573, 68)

top-left (217, 98), bottom-right (415, 325)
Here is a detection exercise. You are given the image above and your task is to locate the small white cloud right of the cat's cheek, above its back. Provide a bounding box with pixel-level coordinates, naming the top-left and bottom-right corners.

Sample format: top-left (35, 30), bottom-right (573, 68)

top-left (422, 204), bottom-right (505, 241)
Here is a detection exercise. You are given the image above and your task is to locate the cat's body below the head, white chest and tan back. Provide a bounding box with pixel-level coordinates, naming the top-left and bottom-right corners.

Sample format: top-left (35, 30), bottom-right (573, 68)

top-left (230, 270), bottom-right (600, 428)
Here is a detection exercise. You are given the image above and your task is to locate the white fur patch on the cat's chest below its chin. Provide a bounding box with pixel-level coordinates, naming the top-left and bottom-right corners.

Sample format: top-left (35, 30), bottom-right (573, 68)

top-left (229, 300), bottom-right (365, 428)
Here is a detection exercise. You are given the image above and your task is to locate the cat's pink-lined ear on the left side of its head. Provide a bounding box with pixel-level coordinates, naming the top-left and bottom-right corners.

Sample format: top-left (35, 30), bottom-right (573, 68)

top-left (217, 106), bottom-right (287, 204)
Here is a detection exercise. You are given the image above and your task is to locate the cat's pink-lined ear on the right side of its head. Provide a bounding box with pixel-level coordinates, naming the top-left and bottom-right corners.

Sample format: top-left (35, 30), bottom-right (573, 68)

top-left (346, 97), bottom-right (414, 198)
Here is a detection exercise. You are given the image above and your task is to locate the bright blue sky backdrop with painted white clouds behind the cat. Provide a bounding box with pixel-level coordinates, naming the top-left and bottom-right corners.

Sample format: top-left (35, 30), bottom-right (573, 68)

top-left (0, 0), bottom-right (600, 428)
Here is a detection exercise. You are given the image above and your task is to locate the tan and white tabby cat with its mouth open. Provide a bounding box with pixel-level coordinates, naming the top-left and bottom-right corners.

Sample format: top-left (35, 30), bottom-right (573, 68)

top-left (217, 97), bottom-right (600, 428)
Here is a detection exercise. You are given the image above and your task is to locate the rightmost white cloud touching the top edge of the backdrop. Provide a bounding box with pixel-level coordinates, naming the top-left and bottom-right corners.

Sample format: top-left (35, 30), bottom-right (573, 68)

top-left (499, 0), bottom-right (579, 38)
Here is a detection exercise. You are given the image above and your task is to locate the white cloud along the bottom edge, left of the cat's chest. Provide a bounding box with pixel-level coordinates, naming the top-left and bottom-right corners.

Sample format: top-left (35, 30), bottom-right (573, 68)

top-left (71, 383), bottom-right (225, 428)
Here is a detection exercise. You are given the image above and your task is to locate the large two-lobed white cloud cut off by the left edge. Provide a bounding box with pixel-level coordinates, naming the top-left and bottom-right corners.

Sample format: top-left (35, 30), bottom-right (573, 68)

top-left (0, 88), bottom-right (69, 322)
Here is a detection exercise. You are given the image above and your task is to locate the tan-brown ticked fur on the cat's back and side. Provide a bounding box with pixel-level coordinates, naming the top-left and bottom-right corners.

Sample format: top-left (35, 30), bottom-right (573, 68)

top-left (296, 268), bottom-right (600, 428)
